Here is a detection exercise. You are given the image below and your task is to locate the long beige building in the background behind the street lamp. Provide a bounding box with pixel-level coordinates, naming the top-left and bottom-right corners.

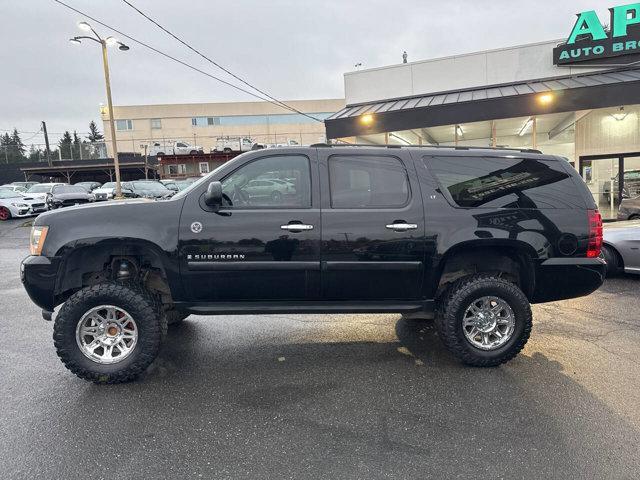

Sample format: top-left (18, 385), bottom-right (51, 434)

top-left (101, 99), bottom-right (345, 155)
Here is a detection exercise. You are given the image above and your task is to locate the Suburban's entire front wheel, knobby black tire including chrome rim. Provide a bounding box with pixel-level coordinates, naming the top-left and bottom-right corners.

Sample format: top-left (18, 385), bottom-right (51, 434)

top-left (53, 283), bottom-right (167, 384)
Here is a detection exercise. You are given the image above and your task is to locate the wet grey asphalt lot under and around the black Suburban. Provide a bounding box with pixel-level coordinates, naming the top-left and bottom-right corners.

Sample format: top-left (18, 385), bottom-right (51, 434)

top-left (0, 220), bottom-right (640, 479)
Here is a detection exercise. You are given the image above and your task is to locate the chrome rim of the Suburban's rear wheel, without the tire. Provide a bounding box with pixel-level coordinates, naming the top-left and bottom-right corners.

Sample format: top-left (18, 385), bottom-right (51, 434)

top-left (462, 296), bottom-right (515, 350)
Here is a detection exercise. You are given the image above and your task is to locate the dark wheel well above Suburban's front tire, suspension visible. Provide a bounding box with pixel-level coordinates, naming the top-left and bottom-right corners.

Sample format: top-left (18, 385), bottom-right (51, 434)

top-left (55, 243), bottom-right (173, 304)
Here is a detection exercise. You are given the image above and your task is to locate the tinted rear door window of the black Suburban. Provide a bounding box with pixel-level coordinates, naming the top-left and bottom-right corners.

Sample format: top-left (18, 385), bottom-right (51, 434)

top-left (329, 155), bottom-right (409, 208)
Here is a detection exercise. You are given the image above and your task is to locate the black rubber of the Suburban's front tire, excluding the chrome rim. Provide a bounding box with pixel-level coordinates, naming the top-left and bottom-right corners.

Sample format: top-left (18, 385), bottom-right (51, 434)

top-left (53, 282), bottom-right (167, 384)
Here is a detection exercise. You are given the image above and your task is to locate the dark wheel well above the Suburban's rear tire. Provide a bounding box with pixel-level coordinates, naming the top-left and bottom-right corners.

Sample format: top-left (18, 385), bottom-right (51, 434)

top-left (435, 246), bottom-right (535, 298)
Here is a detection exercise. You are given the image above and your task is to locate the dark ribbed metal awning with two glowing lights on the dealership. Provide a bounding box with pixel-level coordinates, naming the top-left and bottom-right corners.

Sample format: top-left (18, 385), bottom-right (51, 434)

top-left (325, 68), bottom-right (640, 138)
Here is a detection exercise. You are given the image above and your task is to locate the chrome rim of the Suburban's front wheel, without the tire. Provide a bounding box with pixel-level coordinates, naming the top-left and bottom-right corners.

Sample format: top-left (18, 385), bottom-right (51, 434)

top-left (76, 305), bottom-right (138, 364)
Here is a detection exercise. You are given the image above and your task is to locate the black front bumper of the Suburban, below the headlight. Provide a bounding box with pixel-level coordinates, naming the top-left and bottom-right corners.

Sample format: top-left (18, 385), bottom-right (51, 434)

top-left (20, 255), bottom-right (60, 311)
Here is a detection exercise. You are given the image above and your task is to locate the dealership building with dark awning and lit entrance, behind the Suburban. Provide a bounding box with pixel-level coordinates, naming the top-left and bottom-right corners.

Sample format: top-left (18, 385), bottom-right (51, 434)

top-left (325, 4), bottom-right (640, 221)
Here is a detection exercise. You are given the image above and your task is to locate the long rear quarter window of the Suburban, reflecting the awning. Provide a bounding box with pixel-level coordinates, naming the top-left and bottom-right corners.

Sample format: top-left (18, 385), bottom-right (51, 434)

top-left (423, 157), bottom-right (585, 209)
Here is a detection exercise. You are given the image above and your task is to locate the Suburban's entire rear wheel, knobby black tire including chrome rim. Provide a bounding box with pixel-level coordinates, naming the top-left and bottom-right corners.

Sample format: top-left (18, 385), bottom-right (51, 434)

top-left (436, 275), bottom-right (532, 367)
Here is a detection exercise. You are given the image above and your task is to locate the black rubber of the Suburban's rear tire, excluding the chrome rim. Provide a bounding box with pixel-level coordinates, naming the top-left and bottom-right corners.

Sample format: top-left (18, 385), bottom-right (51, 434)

top-left (436, 274), bottom-right (532, 367)
